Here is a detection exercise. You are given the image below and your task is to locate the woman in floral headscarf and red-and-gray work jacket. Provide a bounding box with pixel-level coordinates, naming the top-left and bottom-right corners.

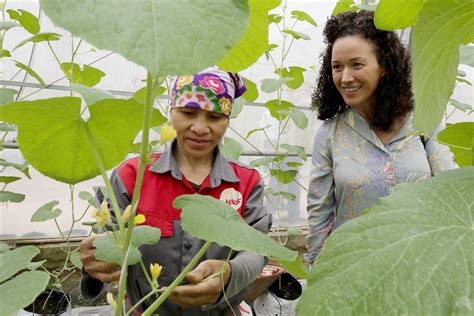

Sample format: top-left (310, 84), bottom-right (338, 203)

top-left (81, 67), bottom-right (271, 315)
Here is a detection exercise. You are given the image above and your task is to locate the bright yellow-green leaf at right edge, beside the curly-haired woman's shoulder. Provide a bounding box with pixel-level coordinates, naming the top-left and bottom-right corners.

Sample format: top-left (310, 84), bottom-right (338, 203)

top-left (437, 122), bottom-right (474, 167)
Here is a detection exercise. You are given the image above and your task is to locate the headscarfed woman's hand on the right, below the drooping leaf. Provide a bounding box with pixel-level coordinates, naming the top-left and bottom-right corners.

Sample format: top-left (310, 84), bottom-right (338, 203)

top-left (170, 259), bottom-right (232, 308)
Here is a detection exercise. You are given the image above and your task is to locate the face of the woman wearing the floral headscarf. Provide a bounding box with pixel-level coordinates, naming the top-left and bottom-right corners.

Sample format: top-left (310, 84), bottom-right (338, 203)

top-left (171, 108), bottom-right (229, 159)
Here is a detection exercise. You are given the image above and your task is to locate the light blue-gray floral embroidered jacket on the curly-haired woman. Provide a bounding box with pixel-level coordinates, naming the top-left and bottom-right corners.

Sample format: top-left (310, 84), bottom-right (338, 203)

top-left (305, 108), bottom-right (457, 262)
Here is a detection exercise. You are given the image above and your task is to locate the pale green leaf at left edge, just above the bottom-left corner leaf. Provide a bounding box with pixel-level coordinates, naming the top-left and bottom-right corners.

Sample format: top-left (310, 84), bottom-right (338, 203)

top-left (0, 246), bottom-right (39, 282)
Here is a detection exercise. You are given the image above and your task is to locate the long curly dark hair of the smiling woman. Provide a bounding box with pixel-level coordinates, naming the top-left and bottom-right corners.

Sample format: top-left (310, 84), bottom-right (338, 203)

top-left (311, 10), bottom-right (414, 131)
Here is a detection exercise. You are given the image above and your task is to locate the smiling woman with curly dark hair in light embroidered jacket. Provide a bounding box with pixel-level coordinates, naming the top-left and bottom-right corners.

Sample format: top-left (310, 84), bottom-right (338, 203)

top-left (306, 10), bottom-right (457, 262)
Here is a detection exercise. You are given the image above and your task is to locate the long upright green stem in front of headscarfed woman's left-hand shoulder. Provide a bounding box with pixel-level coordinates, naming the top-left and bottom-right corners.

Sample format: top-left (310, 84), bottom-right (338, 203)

top-left (115, 72), bottom-right (156, 316)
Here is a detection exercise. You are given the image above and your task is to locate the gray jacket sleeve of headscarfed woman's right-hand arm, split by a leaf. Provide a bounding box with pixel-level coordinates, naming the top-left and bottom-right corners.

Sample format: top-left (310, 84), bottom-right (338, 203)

top-left (216, 181), bottom-right (272, 304)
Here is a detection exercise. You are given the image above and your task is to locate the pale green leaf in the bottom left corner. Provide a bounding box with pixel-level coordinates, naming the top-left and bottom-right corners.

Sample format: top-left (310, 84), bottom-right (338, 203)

top-left (0, 271), bottom-right (49, 315)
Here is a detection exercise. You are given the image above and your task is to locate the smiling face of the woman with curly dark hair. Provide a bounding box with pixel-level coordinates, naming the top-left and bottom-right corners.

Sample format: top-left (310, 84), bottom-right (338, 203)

top-left (331, 36), bottom-right (383, 112)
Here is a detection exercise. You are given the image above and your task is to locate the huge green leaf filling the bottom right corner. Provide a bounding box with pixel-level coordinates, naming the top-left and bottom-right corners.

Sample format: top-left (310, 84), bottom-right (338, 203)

top-left (297, 167), bottom-right (474, 315)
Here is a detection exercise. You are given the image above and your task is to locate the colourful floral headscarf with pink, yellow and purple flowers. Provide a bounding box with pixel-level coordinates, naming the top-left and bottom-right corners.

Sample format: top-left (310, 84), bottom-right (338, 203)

top-left (170, 67), bottom-right (247, 118)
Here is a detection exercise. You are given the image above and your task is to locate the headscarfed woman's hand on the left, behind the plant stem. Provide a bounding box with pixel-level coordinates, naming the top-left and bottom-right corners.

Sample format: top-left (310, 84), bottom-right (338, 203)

top-left (79, 236), bottom-right (120, 283)
